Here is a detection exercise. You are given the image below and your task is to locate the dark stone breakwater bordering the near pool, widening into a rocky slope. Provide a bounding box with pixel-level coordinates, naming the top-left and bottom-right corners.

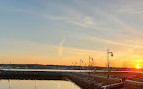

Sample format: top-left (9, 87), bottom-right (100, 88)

top-left (0, 70), bottom-right (122, 89)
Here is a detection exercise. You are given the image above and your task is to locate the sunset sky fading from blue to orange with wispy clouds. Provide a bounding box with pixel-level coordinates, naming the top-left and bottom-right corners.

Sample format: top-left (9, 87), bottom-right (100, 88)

top-left (0, 0), bottom-right (143, 67)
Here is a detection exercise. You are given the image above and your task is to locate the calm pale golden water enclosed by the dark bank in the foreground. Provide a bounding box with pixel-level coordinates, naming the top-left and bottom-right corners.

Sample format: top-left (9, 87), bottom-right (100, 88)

top-left (0, 80), bottom-right (80, 89)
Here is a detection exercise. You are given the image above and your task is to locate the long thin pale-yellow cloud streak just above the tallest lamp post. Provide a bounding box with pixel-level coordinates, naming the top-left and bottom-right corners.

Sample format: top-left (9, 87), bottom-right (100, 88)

top-left (71, 33), bottom-right (143, 49)
